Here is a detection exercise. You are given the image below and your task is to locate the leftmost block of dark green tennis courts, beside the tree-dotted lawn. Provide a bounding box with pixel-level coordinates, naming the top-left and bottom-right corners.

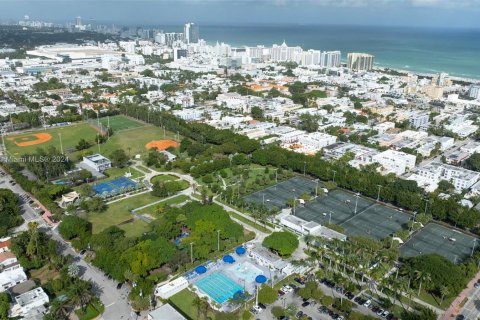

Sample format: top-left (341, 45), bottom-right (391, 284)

top-left (244, 176), bottom-right (321, 209)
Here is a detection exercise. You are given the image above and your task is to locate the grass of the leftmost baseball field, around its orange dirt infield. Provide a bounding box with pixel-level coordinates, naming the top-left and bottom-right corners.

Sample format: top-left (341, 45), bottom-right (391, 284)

top-left (5, 122), bottom-right (98, 156)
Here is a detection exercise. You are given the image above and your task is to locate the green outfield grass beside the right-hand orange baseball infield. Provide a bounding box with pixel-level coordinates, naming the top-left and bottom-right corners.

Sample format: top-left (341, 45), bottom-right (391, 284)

top-left (72, 125), bottom-right (181, 159)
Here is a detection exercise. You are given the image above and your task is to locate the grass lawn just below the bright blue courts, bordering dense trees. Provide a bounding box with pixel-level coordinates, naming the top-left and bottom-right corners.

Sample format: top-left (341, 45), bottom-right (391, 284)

top-left (87, 192), bottom-right (160, 233)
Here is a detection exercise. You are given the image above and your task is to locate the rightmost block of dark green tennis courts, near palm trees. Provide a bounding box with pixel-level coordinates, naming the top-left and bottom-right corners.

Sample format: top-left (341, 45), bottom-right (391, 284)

top-left (400, 223), bottom-right (478, 263)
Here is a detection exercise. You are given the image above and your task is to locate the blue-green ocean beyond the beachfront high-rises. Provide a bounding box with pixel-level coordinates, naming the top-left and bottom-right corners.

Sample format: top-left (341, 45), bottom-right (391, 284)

top-left (193, 25), bottom-right (480, 79)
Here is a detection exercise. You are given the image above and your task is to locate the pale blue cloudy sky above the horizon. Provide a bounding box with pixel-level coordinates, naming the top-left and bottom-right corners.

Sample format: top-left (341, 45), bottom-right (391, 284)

top-left (0, 0), bottom-right (480, 29)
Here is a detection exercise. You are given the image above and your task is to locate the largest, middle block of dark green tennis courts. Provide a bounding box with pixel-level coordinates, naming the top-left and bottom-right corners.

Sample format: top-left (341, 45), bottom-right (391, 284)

top-left (295, 189), bottom-right (410, 240)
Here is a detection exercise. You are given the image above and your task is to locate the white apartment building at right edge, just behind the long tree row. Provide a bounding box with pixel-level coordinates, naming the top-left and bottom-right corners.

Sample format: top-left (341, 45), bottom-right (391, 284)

top-left (417, 162), bottom-right (480, 192)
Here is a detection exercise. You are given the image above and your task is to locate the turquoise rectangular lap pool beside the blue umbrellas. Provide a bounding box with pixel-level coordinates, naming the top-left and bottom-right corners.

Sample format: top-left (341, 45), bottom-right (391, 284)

top-left (195, 272), bottom-right (243, 304)
